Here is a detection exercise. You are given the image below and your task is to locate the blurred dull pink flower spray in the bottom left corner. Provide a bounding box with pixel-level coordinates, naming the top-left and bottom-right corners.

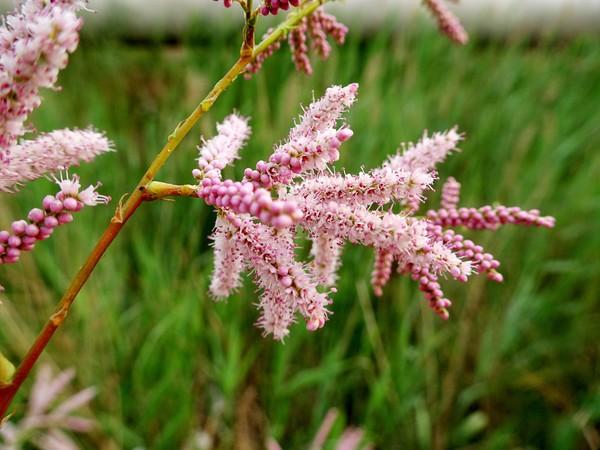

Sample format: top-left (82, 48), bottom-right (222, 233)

top-left (0, 366), bottom-right (96, 450)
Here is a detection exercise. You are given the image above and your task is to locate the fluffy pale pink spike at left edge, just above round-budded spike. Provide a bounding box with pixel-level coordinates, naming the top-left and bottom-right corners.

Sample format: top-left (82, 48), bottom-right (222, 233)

top-left (0, 130), bottom-right (112, 192)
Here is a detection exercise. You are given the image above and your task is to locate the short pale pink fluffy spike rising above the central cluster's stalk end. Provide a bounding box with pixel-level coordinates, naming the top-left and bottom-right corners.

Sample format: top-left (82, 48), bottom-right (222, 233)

top-left (192, 114), bottom-right (251, 179)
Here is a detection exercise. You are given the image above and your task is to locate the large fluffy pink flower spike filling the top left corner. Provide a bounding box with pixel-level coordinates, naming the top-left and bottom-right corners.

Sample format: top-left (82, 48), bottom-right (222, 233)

top-left (0, 0), bottom-right (82, 152)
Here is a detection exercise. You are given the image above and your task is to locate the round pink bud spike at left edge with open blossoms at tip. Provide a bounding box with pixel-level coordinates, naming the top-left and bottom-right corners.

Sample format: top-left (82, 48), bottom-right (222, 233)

top-left (0, 175), bottom-right (110, 292)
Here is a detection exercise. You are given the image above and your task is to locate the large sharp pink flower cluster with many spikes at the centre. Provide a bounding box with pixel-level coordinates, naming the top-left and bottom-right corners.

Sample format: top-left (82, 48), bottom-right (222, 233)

top-left (199, 84), bottom-right (554, 339)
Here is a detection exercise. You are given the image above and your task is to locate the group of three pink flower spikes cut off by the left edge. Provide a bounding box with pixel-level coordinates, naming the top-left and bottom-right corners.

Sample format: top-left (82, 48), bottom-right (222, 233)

top-left (0, 0), bottom-right (112, 290)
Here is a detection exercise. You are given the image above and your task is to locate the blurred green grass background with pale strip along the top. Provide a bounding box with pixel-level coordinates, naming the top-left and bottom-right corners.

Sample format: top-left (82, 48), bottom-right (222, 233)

top-left (0, 0), bottom-right (600, 450)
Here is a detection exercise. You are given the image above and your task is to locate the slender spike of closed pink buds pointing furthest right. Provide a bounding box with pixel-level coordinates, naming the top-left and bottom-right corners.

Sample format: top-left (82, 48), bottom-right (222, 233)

top-left (427, 205), bottom-right (555, 230)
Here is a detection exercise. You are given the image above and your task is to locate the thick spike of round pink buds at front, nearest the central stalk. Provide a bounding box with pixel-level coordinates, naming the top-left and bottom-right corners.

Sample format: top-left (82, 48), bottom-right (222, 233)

top-left (198, 178), bottom-right (302, 229)
